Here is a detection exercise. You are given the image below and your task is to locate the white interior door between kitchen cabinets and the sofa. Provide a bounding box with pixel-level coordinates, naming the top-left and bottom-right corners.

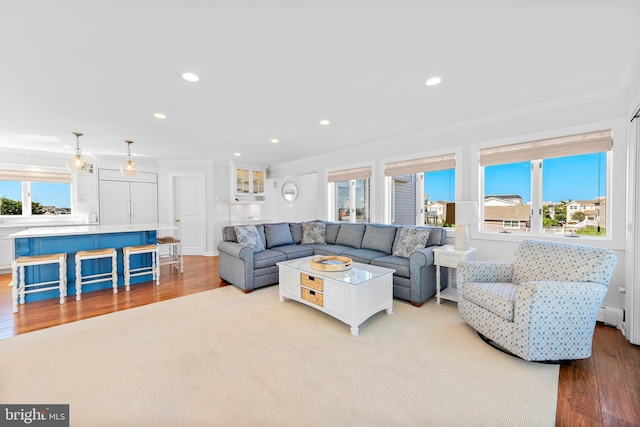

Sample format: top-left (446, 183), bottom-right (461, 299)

top-left (173, 175), bottom-right (206, 255)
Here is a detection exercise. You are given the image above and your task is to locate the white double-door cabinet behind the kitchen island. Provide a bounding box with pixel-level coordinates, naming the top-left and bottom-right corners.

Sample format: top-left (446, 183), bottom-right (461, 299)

top-left (99, 169), bottom-right (158, 225)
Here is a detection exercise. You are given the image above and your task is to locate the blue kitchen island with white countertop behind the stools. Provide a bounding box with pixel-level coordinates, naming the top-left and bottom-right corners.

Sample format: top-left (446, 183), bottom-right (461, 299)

top-left (7, 224), bottom-right (176, 302)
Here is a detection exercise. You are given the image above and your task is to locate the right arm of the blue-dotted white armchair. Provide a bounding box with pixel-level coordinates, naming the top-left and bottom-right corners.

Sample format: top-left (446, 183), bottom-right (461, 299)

top-left (513, 281), bottom-right (607, 360)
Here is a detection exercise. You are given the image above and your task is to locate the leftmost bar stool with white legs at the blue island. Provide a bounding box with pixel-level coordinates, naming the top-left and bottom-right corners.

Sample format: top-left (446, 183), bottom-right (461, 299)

top-left (11, 253), bottom-right (67, 313)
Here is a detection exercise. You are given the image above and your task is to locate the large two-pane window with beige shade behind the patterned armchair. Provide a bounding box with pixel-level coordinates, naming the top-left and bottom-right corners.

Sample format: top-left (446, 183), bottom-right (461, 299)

top-left (480, 130), bottom-right (613, 236)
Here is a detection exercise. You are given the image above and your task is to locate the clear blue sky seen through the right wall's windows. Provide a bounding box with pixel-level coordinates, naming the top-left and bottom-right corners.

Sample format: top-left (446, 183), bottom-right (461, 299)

top-left (425, 153), bottom-right (607, 203)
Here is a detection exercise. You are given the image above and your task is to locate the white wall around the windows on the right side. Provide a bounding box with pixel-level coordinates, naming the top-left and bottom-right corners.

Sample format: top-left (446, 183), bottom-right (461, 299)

top-left (269, 94), bottom-right (629, 308)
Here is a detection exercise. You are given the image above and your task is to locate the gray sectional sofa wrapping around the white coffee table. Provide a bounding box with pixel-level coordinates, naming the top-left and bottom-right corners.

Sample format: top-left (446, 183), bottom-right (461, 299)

top-left (218, 221), bottom-right (447, 307)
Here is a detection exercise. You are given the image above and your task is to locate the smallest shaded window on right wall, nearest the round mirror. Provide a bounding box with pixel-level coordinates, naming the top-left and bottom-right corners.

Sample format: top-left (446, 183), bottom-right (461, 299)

top-left (328, 167), bottom-right (371, 222)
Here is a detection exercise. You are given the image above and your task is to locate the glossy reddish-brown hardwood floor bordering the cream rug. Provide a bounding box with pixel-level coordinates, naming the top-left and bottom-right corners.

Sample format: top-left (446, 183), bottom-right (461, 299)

top-left (0, 256), bottom-right (640, 427)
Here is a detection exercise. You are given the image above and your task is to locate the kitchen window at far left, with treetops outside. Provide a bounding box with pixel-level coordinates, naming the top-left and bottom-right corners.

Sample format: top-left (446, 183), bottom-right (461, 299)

top-left (0, 170), bottom-right (71, 216)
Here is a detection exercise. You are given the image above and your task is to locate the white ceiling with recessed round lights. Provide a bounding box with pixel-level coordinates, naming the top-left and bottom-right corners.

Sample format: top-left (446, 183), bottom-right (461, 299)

top-left (0, 0), bottom-right (640, 166)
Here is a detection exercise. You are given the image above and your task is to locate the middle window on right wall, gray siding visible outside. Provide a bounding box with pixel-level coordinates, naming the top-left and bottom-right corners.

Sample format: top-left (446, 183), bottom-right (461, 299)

top-left (384, 154), bottom-right (456, 226)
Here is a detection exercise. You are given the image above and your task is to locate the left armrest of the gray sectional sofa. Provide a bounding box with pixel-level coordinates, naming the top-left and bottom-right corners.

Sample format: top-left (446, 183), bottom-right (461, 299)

top-left (218, 241), bottom-right (253, 293)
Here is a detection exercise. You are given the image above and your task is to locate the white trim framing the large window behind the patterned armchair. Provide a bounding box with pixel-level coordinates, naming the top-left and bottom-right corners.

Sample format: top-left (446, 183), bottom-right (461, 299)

top-left (470, 118), bottom-right (627, 250)
